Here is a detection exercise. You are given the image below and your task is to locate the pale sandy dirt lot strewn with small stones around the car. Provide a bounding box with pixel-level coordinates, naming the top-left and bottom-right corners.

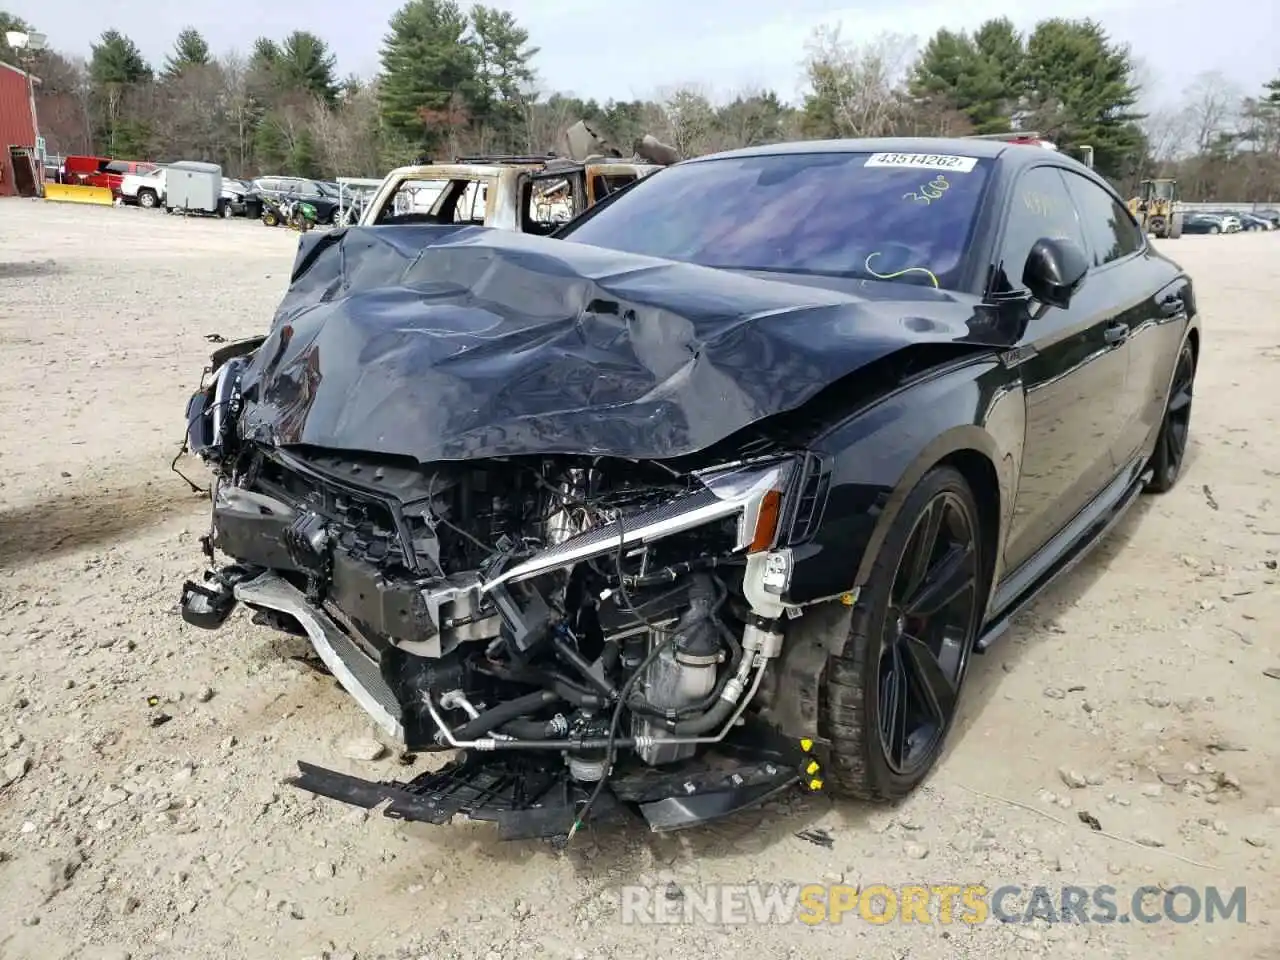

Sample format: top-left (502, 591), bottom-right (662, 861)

top-left (0, 201), bottom-right (1280, 960)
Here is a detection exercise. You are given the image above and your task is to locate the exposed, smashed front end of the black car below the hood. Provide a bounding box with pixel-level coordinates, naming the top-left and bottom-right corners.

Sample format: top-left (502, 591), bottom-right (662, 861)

top-left (183, 357), bottom-right (815, 835)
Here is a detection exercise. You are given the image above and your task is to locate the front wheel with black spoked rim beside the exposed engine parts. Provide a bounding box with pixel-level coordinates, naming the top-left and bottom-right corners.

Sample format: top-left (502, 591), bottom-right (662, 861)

top-left (820, 467), bottom-right (986, 801)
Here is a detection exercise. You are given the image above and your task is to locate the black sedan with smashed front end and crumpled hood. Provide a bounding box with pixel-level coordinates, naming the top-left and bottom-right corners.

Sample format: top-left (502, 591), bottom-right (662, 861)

top-left (183, 140), bottom-right (1201, 837)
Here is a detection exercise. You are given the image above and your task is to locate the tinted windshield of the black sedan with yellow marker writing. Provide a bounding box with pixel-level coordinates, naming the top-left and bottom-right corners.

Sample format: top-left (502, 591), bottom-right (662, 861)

top-left (561, 152), bottom-right (989, 287)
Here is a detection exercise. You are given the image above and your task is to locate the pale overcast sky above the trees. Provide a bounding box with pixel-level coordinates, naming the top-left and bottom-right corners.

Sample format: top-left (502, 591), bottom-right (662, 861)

top-left (0, 0), bottom-right (1280, 110)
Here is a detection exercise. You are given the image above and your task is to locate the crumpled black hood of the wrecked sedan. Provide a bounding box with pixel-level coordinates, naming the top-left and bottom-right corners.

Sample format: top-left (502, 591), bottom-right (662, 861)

top-left (242, 225), bottom-right (989, 463)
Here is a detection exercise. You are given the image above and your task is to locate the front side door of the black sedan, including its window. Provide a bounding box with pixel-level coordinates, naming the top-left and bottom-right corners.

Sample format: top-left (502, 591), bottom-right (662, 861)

top-left (996, 165), bottom-right (1129, 573)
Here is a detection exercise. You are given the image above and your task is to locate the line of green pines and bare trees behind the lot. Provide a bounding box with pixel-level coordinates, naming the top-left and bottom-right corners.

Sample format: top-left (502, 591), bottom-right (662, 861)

top-left (0, 0), bottom-right (1280, 200)
